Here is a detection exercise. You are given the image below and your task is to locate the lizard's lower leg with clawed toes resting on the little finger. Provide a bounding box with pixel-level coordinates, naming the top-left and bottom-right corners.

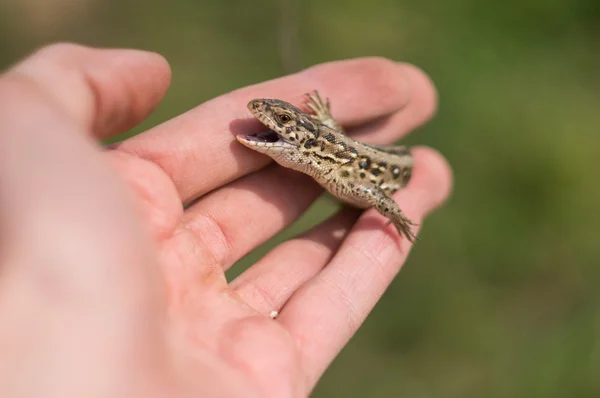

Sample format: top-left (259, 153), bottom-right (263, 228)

top-left (336, 182), bottom-right (417, 242)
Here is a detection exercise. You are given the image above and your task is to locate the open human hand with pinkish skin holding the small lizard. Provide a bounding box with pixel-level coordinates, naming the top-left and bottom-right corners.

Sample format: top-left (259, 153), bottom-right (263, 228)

top-left (0, 44), bottom-right (451, 398)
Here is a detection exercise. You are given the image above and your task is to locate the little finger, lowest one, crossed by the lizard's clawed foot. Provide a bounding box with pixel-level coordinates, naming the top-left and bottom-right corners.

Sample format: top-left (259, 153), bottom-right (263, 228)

top-left (279, 148), bottom-right (451, 384)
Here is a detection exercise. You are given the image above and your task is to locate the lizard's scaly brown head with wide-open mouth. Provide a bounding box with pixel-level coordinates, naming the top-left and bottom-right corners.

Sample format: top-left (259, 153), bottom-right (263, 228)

top-left (236, 98), bottom-right (319, 161)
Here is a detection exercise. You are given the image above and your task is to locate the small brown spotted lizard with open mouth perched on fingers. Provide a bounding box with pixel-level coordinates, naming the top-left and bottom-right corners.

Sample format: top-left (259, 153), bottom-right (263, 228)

top-left (236, 91), bottom-right (416, 242)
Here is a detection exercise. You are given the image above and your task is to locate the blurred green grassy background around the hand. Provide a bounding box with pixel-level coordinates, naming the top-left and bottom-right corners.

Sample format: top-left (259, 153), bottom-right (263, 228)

top-left (0, 0), bottom-right (600, 397)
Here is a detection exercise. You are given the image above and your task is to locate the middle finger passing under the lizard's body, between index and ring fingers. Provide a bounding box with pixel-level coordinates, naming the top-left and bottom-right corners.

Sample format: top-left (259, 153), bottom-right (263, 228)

top-left (178, 63), bottom-right (434, 269)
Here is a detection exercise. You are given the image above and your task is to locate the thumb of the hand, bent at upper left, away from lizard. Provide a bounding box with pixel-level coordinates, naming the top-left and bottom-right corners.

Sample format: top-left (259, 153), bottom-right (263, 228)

top-left (6, 44), bottom-right (170, 138)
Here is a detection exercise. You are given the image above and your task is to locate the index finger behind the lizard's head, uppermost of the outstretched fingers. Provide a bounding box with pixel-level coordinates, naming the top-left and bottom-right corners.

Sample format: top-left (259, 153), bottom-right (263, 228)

top-left (119, 58), bottom-right (435, 202)
